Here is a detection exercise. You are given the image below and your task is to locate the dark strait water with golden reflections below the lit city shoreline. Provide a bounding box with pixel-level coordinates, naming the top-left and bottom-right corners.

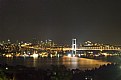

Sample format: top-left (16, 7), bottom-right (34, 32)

top-left (0, 57), bottom-right (110, 70)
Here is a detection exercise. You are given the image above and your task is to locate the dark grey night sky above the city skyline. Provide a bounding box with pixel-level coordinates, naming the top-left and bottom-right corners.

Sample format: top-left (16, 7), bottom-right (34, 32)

top-left (0, 0), bottom-right (121, 44)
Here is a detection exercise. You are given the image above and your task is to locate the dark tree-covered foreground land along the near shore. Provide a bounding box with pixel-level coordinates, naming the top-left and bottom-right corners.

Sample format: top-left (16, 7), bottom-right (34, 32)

top-left (0, 64), bottom-right (121, 80)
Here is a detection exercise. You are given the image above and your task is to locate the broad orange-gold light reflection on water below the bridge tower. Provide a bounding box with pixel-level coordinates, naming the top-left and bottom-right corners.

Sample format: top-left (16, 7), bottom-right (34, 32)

top-left (63, 57), bottom-right (110, 70)
